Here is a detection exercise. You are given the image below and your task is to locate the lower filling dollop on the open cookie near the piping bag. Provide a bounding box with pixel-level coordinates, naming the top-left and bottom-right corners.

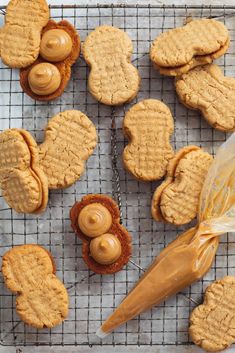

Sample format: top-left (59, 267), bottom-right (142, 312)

top-left (90, 233), bottom-right (122, 265)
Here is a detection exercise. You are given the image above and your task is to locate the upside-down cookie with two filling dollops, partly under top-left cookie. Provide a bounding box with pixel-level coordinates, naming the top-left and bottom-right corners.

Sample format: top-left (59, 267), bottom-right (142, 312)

top-left (20, 20), bottom-right (80, 101)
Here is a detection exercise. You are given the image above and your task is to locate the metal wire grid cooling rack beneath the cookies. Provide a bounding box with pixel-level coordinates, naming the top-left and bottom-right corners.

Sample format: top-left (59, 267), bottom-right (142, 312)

top-left (0, 5), bottom-right (235, 346)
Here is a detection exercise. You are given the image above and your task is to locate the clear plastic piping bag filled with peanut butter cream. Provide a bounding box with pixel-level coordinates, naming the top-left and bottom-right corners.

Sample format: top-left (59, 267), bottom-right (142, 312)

top-left (96, 133), bottom-right (235, 338)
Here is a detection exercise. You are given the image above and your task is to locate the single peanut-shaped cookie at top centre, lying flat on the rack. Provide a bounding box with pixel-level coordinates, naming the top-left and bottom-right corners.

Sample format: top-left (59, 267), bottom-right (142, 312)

top-left (83, 25), bottom-right (140, 105)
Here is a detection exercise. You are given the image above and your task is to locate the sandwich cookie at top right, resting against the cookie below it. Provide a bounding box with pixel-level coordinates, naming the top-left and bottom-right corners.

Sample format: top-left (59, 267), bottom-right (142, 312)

top-left (150, 19), bottom-right (229, 76)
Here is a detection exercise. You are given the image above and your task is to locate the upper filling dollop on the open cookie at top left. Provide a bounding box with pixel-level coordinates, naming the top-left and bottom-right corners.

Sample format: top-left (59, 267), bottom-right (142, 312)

top-left (40, 29), bottom-right (73, 62)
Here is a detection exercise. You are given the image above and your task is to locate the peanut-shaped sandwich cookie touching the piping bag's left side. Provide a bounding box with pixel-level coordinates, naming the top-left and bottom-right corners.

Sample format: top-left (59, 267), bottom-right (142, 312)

top-left (152, 146), bottom-right (213, 225)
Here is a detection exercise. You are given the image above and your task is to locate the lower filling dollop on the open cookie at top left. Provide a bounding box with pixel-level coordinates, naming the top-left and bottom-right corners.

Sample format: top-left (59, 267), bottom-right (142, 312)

top-left (28, 63), bottom-right (61, 96)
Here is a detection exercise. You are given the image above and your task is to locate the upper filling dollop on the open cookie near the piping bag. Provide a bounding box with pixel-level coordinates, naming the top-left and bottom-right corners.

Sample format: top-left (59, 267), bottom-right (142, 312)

top-left (78, 203), bottom-right (113, 238)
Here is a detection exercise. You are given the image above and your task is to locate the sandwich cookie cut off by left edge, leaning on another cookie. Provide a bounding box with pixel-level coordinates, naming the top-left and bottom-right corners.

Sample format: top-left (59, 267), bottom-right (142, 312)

top-left (0, 129), bottom-right (48, 213)
